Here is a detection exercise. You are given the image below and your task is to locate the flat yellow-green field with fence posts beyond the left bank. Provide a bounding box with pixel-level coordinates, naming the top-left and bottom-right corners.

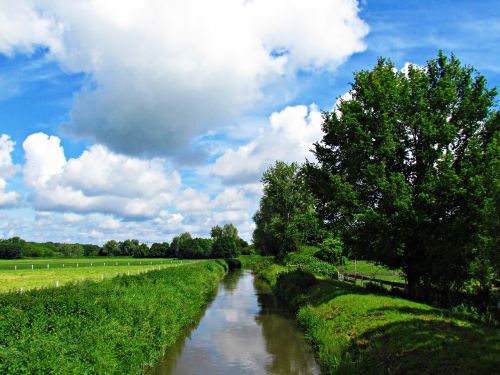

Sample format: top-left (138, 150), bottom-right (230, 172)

top-left (0, 258), bottom-right (199, 293)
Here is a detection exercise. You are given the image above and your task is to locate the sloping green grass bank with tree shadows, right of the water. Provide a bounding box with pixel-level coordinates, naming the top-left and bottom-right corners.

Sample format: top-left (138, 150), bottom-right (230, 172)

top-left (259, 249), bottom-right (500, 374)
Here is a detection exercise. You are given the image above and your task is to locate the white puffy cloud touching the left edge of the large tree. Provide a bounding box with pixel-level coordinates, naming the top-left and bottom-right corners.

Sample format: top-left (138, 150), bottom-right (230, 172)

top-left (212, 104), bottom-right (323, 183)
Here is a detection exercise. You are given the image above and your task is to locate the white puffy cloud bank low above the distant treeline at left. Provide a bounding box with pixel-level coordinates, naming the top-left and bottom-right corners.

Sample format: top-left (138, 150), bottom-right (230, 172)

top-left (23, 133), bottom-right (181, 219)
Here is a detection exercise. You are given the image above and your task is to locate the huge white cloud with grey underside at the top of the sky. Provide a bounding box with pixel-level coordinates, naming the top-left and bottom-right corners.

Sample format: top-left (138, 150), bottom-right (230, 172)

top-left (0, 0), bottom-right (368, 159)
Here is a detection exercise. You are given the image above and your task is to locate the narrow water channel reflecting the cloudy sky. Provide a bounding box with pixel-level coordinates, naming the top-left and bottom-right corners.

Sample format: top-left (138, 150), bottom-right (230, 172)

top-left (152, 270), bottom-right (320, 375)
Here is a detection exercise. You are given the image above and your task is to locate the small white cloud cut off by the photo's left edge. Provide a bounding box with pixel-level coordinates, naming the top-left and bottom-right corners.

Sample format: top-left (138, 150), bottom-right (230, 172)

top-left (0, 134), bottom-right (19, 208)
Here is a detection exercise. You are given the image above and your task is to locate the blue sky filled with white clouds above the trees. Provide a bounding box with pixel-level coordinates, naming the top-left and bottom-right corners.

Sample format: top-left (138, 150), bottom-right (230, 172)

top-left (0, 0), bottom-right (500, 244)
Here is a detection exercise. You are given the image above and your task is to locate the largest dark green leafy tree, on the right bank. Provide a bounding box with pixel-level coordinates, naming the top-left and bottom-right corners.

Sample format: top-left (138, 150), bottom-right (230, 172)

top-left (307, 52), bottom-right (500, 292)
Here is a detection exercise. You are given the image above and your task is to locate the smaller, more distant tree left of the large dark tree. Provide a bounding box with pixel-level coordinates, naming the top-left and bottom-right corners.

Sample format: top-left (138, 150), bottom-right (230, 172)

top-left (253, 161), bottom-right (323, 256)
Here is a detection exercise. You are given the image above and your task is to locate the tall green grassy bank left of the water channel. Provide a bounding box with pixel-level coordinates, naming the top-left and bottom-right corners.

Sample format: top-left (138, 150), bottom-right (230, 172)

top-left (0, 261), bottom-right (224, 374)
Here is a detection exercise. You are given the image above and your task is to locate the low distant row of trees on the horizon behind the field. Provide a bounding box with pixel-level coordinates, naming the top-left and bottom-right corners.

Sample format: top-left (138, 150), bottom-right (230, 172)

top-left (0, 224), bottom-right (253, 259)
